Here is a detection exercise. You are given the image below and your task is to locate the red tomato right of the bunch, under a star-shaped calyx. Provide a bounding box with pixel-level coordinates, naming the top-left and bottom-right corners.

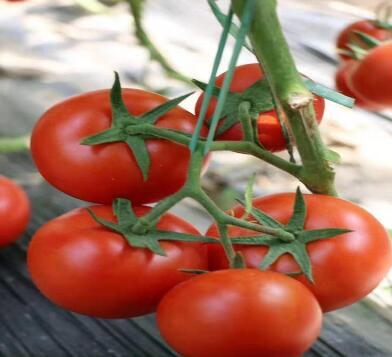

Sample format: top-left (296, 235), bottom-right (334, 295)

top-left (206, 193), bottom-right (392, 311)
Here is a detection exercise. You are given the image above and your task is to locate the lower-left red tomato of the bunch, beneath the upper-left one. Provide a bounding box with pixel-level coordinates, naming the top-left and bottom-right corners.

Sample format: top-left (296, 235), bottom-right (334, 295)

top-left (27, 205), bottom-right (207, 318)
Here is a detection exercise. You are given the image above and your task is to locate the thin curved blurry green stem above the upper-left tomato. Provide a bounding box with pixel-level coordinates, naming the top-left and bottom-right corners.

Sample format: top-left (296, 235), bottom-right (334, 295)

top-left (126, 0), bottom-right (191, 84)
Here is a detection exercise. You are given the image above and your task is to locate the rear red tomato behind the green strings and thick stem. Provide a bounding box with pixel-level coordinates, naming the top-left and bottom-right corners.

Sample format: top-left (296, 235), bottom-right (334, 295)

top-left (195, 63), bottom-right (325, 152)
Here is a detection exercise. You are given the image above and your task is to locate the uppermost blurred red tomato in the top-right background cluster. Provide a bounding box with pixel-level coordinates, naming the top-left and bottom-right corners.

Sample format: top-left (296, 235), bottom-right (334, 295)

top-left (336, 20), bottom-right (390, 61)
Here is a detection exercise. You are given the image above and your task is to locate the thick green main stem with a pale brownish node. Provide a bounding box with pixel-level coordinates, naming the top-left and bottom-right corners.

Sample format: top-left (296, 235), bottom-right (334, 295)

top-left (232, 0), bottom-right (336, 195)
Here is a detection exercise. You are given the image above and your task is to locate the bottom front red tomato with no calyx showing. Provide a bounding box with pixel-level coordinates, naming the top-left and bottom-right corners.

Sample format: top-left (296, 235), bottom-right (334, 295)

top-left (157, 269), bottom-right (322, 357)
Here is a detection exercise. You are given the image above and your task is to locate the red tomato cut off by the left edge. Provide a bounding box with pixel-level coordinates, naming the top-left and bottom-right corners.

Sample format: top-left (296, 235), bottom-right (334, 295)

top-left (0, 176), bottom-right (31, 247)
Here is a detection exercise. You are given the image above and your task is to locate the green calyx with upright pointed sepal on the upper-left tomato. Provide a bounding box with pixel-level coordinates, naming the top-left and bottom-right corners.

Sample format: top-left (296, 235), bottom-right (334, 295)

top-left (81, 72), bottom-right (192, 181)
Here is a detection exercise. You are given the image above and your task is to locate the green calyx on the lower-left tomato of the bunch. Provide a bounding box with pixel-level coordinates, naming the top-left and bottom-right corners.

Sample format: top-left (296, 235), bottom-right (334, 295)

top-left (87, 198), bottom-right (216, 256)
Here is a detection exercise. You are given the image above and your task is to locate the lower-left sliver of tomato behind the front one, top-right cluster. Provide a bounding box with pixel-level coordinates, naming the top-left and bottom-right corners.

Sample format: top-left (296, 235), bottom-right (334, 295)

top-left (335, 60), bottom-right (382, 110)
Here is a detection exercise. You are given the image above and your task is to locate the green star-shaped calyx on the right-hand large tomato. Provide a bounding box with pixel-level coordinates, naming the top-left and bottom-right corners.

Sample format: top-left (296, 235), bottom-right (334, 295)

top-left (231, 189), bottom-right (351, 283)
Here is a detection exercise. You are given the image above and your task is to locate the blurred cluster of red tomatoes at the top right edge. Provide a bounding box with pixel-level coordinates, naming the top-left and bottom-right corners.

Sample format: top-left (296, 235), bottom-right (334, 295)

top-left (336, 20), bottom-right (392, 111)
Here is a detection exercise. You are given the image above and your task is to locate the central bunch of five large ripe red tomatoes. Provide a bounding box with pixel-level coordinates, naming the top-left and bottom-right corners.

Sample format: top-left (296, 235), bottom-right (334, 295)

top-left (28, 64), bottom-right (392, 357)
